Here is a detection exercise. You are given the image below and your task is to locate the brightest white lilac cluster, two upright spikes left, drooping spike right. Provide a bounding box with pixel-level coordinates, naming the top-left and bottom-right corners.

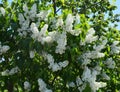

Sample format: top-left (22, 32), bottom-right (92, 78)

top-left (31, 23), bottom-right (67, 54)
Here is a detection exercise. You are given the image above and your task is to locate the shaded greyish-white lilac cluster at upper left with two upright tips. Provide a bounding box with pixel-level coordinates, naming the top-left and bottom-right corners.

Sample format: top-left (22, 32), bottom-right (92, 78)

top-left (17, 4), bottom-right (48, 36)
